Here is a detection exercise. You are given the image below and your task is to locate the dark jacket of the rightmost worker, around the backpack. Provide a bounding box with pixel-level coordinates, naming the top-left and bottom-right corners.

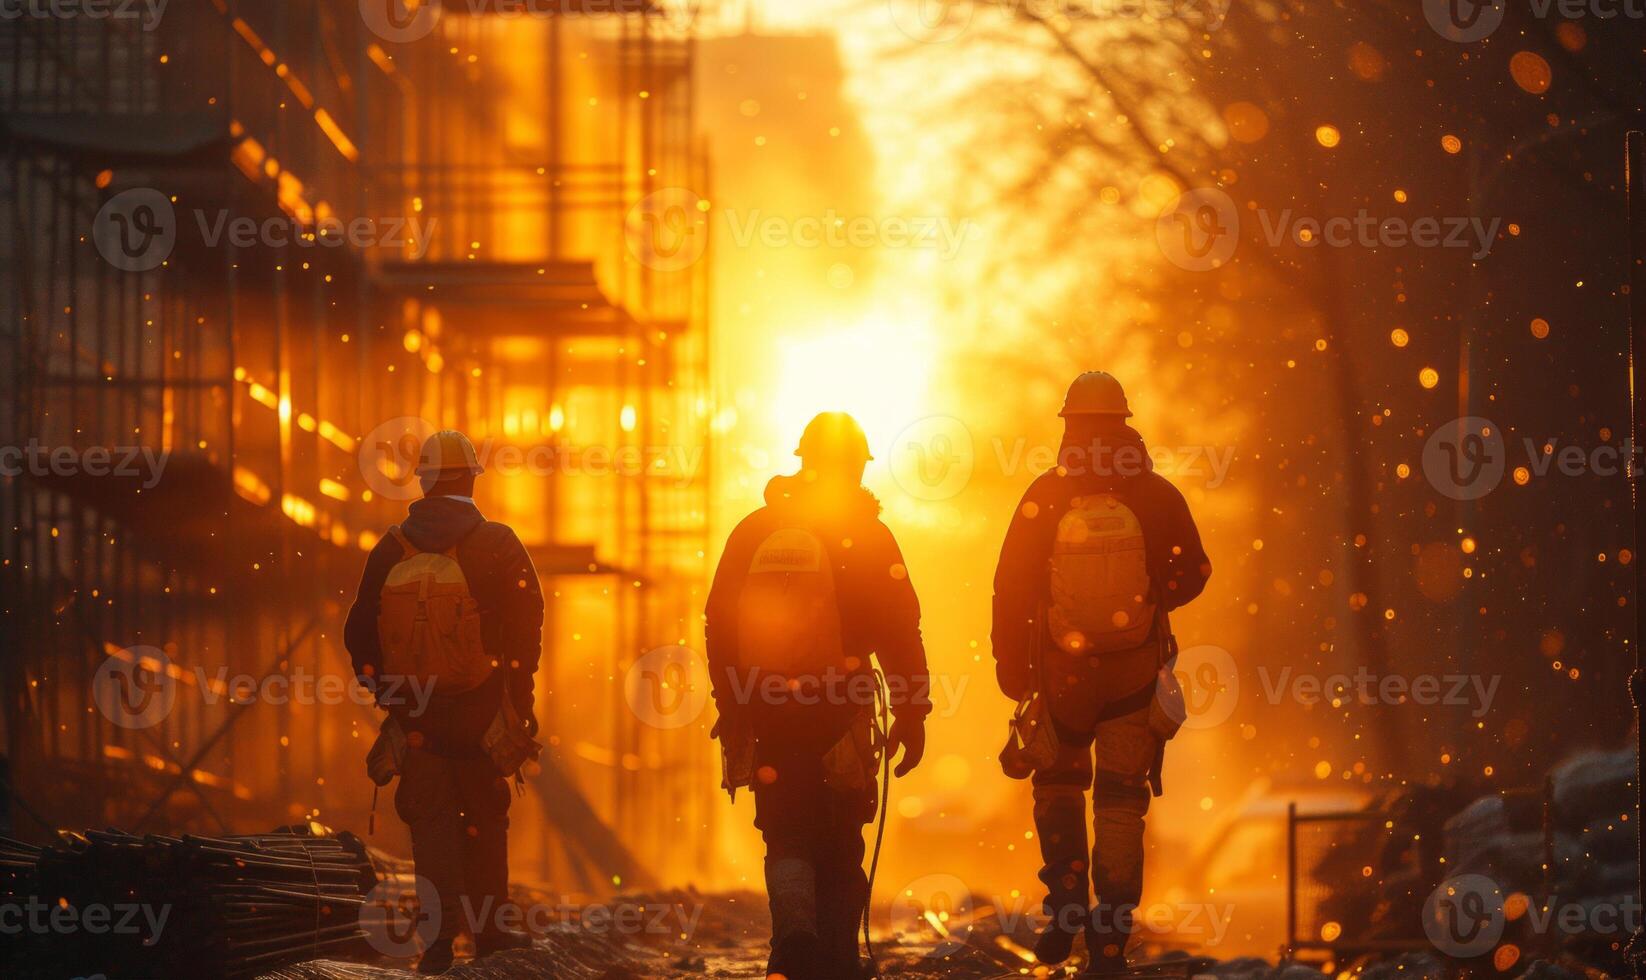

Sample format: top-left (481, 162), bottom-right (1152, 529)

top-left (991, 427), bottom-right (1211, 698)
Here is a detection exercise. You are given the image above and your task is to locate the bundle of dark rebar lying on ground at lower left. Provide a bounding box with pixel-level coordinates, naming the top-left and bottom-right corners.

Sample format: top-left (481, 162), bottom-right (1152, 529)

top-left (0, 828), bottom-right (377, 980)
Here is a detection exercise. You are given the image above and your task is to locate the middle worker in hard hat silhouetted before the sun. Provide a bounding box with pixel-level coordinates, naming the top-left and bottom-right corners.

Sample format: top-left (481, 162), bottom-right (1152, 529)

top-left (704, 412), bottom-right (932, 980)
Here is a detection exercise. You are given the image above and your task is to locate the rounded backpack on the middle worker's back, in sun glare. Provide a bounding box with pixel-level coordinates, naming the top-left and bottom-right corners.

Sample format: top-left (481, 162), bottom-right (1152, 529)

top-left (737, 527), bottom-right (846, 677)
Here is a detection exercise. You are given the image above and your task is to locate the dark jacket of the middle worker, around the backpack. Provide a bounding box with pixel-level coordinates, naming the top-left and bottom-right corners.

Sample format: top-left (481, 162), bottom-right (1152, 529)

top-left (704, 476), bottom-right (932, 741)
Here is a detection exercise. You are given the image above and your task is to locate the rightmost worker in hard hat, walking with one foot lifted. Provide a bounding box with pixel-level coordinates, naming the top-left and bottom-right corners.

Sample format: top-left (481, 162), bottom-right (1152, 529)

top-left (993, 372), bottom-right (1211, 975)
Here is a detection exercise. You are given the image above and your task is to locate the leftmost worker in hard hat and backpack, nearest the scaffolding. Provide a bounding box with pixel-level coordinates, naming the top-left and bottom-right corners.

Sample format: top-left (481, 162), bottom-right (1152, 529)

top-left (344, 430), bottom-right (543, 973)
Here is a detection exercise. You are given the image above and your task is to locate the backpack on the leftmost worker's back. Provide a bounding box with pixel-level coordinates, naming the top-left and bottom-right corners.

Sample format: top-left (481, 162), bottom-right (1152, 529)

top-left (377, 525), bottom-right (497, 695)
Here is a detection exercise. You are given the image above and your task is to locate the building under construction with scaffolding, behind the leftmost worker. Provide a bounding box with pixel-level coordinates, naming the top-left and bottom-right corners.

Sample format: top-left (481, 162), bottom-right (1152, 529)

top-left (0, 0), bottom-right (714, 893)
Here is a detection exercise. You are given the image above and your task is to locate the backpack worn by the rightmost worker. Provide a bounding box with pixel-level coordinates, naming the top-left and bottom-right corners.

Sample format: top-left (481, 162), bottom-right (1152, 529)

top-left (1047, 494), bottom-right (1155, 656)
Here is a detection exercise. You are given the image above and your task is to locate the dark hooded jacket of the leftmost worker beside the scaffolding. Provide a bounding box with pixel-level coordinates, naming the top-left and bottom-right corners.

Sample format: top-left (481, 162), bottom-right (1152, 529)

top-left (342, 497), bottom-right (543, 756)
